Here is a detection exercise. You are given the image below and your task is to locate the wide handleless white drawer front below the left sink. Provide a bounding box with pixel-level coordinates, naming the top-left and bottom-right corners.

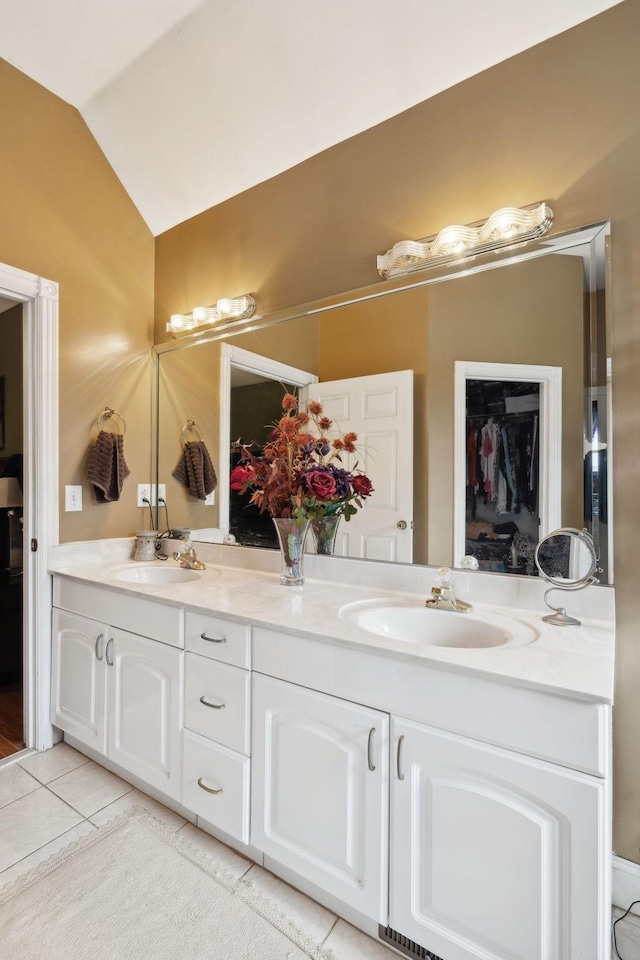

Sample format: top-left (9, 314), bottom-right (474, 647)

top-left (53, 576), bottom-right (184, 647)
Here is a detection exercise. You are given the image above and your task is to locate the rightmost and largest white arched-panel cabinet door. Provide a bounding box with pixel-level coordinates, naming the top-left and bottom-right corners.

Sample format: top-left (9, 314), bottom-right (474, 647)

top-left (389, 719), bottom-right (610, 960)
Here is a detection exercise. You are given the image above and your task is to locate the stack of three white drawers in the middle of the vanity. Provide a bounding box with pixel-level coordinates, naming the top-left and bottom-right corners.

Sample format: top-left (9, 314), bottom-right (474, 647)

top-left (182, 611), bottom-right (251, 843)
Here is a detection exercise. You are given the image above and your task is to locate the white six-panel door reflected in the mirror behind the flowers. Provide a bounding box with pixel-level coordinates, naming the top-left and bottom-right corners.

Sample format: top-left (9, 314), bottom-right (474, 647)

top-left (302, 370), bottom-right (413, 563)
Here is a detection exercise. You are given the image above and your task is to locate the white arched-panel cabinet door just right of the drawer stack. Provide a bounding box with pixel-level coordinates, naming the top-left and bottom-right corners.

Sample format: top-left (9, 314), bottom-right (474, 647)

top-left (251, 675), bottom-right (389, 923)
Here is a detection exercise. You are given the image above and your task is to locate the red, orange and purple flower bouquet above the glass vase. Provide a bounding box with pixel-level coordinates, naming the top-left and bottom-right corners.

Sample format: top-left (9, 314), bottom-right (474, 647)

top-left (230, 393), bottom-right (373, 527)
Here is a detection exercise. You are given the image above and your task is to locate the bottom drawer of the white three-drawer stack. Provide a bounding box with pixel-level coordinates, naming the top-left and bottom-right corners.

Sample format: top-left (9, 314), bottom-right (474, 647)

top-left (182, 730), bottom-right (249, 843)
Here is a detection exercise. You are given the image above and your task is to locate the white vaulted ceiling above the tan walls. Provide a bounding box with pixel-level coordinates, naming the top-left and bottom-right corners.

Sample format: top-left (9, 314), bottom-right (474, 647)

top-left (0, 0), bottom-right (619, 234)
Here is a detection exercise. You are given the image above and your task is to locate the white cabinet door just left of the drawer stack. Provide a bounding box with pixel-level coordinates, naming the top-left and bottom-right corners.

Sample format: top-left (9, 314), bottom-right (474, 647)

top-left (105, 629), bottom-right (183, 800)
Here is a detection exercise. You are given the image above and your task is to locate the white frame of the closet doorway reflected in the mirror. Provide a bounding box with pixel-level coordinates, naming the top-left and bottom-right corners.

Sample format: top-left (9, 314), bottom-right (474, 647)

top-left (453, 360), bottom-right (562, 566)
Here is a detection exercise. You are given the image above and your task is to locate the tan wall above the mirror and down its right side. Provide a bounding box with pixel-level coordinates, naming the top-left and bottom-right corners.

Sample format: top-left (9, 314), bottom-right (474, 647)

top-left (156, 0), bottom-right (640, 859)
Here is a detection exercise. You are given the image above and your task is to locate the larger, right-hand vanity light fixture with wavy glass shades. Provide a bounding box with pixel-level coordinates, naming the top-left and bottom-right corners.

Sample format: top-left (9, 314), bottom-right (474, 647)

top-left (378, 203), bottom-right (553, 280)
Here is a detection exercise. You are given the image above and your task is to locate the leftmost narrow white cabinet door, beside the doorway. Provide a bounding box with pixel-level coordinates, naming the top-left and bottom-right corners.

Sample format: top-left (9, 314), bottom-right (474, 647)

top-left (51, 609), bottom-right (108, 753)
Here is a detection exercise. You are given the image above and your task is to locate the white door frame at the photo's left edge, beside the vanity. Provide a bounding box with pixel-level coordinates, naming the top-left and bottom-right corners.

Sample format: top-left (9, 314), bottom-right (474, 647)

top-left (0, 264), bottom-right (59, 750)
